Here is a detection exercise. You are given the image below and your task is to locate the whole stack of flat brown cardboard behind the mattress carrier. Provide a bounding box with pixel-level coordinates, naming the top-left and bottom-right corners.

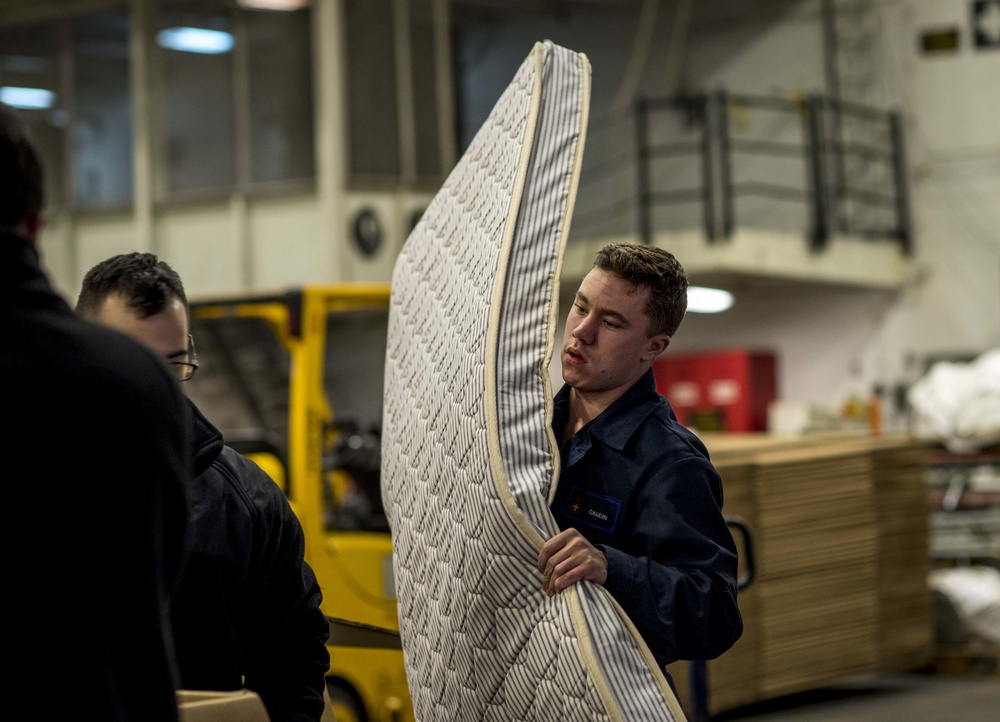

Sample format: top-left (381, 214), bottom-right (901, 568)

top-left (668, 434), bottom-right (933, 715)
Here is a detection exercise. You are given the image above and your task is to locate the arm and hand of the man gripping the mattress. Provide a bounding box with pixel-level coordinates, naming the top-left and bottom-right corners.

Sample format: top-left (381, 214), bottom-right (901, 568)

top-left (538, 458), bottom-right (743, 659)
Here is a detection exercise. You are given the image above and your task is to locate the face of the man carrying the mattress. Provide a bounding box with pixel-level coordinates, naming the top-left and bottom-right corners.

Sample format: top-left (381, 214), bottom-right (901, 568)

top-left (561, 268), bottom-right (670, 403)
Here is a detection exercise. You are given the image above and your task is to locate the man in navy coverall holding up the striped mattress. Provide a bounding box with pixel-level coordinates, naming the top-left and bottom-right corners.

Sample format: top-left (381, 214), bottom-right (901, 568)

top-left (538, 243), bottom-right (743, 665)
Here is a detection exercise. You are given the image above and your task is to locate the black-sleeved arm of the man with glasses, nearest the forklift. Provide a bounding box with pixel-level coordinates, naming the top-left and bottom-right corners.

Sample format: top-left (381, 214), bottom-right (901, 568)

top-left (239, 457), bottom-right (330, 722)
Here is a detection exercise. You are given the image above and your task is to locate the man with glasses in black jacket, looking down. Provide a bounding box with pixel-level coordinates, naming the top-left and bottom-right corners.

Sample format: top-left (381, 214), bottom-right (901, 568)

top-left (77, 253), bottom-right (330, 722)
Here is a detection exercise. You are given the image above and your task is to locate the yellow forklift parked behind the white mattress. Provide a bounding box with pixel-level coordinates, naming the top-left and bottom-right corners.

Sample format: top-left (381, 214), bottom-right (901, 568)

top-left (186, 284), bottom-right (413, 722)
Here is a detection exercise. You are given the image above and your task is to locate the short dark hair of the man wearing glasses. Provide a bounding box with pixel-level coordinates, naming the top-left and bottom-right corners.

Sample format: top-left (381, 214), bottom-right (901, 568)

top-left (76, 253), bottom-right (188, 319)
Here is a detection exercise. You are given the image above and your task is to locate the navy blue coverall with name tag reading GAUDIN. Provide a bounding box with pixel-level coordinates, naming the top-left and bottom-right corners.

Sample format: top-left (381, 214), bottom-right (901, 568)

top-left (551, 370), bottom-right (743, 665)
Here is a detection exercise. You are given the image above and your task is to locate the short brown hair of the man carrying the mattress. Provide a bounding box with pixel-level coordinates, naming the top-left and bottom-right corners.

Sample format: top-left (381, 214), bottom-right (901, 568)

top-left (594, 243), bottom-right (688, 337)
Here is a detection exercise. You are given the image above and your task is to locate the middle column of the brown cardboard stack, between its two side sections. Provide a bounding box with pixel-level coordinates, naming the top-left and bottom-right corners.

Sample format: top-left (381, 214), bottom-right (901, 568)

top-left (754, 445), bottom-right (878, 697)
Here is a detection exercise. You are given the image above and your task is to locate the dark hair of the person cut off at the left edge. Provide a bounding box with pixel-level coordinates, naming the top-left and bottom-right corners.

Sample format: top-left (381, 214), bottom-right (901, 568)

top-left (0, 103), bottom-right (45, 226)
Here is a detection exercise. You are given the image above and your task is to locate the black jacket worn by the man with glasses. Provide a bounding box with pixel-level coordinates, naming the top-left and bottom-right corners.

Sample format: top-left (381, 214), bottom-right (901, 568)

top-left (173, 404), bottom-right (330, 722)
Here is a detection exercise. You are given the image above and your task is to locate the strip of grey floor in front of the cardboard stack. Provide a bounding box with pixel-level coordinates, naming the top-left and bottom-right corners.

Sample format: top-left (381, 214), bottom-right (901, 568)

top-left (711, 674), bottom-right (1000, 722)
